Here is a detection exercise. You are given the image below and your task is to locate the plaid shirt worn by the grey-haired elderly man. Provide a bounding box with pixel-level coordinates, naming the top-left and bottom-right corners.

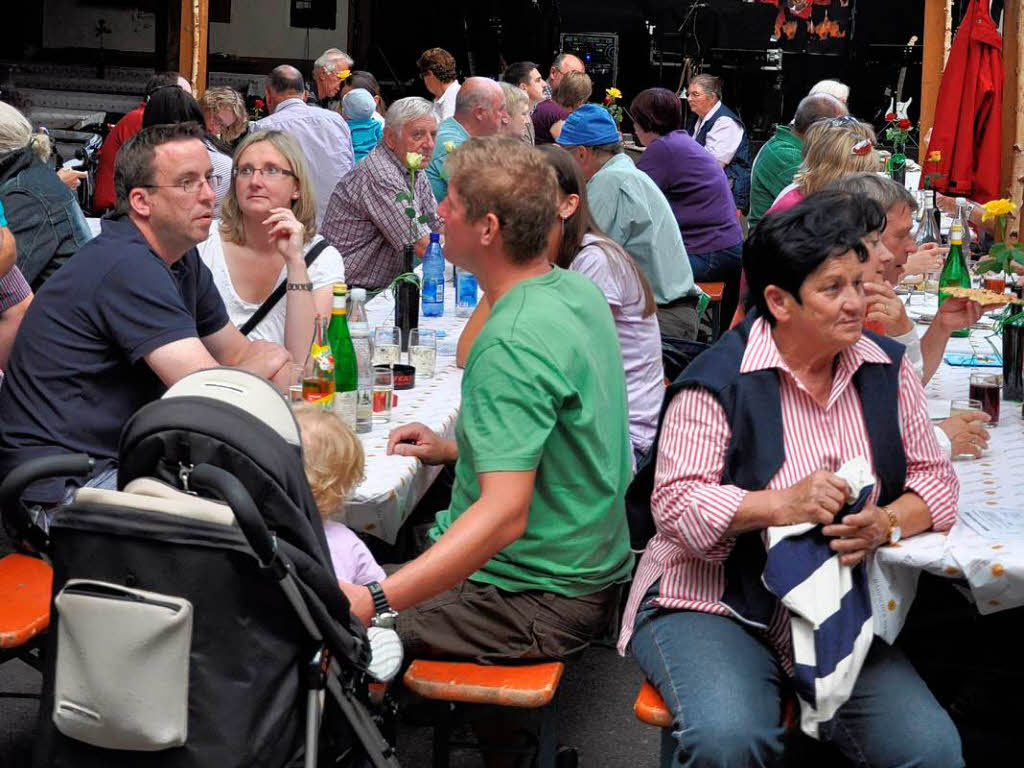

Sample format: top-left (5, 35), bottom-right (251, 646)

top-left (319, 142), bottom-right (439, 291)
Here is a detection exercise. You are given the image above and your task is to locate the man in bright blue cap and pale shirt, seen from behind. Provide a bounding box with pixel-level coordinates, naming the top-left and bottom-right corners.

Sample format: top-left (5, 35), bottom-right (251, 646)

top-left (557, 104), bottom-right (700, 339)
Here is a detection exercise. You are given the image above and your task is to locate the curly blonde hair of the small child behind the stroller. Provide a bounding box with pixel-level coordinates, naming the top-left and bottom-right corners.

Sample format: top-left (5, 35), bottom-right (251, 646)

top-left (294, 403), bottom-right (366, 517)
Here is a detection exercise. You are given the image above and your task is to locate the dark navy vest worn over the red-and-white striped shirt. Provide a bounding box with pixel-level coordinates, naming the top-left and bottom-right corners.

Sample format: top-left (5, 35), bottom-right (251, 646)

top-left (628, 311), bottom-right (906, 624)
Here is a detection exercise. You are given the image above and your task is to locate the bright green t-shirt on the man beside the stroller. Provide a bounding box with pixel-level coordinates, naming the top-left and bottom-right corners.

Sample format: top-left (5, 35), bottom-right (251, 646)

top-left (430, 267), bottom-right (633, 597)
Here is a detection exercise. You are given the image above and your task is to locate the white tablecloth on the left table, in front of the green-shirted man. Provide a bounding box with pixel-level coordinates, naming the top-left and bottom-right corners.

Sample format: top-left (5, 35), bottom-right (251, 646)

top-left (339, 282), bottom-right (475, 544)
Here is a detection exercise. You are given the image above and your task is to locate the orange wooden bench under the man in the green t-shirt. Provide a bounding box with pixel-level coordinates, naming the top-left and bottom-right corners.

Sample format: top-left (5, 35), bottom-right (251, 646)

top-left (402, 658), bottom-right (565, 768)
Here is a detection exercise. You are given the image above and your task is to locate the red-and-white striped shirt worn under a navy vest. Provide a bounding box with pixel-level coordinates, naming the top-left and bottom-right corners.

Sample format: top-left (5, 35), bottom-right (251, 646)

top-left (618, 319), bottom-right (959, 669)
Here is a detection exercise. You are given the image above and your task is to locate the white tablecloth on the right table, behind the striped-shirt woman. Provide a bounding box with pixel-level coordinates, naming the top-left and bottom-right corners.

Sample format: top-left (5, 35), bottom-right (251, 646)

top-left (869, 298), bottom-right (1024, 641)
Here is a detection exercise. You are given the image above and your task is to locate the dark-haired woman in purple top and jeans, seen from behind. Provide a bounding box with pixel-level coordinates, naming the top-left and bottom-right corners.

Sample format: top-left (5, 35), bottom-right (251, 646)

top-left (630, 88), bottom-right (743, 317)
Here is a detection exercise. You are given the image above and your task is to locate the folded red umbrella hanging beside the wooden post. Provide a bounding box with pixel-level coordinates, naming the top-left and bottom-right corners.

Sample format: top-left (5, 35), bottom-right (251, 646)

top-left (922, 0), bottom-right (1002, 203)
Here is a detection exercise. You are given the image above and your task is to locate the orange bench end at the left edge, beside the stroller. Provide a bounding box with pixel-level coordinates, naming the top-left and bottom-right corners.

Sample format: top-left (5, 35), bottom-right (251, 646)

top-left (0, 553), bottom-right (53, 667)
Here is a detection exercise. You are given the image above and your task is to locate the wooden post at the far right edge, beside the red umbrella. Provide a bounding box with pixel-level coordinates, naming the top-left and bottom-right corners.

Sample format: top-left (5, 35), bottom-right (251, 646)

top-left (999, 0), bottom-right (1024, 242)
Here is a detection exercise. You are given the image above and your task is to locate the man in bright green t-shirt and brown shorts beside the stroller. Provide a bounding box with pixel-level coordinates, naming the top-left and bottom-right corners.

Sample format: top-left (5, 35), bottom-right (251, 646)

top-left (344, 138), bottom-right (633, 663)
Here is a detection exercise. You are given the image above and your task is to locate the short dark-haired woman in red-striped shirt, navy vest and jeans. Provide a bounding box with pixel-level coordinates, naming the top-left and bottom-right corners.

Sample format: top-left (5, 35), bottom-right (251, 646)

top-left (620, 193), bottom-right (964, 766)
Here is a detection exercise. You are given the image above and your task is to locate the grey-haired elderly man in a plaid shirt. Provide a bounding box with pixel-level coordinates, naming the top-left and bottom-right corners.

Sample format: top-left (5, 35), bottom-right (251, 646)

top-left (319, 96), bottom-right (439, 291)
